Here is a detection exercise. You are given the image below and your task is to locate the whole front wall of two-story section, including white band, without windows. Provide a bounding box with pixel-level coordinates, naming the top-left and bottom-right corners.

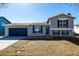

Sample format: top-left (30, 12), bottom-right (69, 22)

top-left (49, 15), bottom-right (74, 37)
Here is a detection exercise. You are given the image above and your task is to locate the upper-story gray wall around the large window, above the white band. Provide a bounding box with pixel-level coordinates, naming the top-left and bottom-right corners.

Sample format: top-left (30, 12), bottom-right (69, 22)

top-left (49, 16), bottom-right (74, 28)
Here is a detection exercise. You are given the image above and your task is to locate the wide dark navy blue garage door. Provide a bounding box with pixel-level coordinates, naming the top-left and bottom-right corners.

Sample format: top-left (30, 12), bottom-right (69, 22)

top-left (9, 28), bottom-right (27, 36)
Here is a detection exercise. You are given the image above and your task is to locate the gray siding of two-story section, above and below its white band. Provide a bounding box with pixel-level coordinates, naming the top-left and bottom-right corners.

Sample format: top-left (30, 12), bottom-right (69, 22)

top-left (49, 15), bottom-right (74, 37)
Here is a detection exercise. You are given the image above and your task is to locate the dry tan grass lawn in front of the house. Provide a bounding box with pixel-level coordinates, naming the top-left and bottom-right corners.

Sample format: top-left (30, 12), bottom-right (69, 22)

top-left (0, 37), bottom-right (79, 56)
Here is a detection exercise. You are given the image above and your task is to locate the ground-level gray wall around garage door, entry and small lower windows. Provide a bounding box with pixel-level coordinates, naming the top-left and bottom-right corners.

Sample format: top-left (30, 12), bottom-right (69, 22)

top-left (5, 26), bottom-right (74, 37)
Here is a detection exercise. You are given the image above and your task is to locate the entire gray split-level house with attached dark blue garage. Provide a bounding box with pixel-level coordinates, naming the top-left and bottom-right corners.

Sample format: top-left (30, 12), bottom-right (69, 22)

top-left (5, 14), bottom-right (75, 37)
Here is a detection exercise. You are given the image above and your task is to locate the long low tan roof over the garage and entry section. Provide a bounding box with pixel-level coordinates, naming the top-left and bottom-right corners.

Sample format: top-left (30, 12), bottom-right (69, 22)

top-left (5, 23), bottom-right (49, 26)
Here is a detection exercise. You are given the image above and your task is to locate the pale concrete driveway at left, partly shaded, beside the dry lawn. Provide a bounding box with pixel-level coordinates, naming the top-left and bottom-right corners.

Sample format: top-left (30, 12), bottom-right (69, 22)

top-left (0, 37), bottom-right (25, 50)
